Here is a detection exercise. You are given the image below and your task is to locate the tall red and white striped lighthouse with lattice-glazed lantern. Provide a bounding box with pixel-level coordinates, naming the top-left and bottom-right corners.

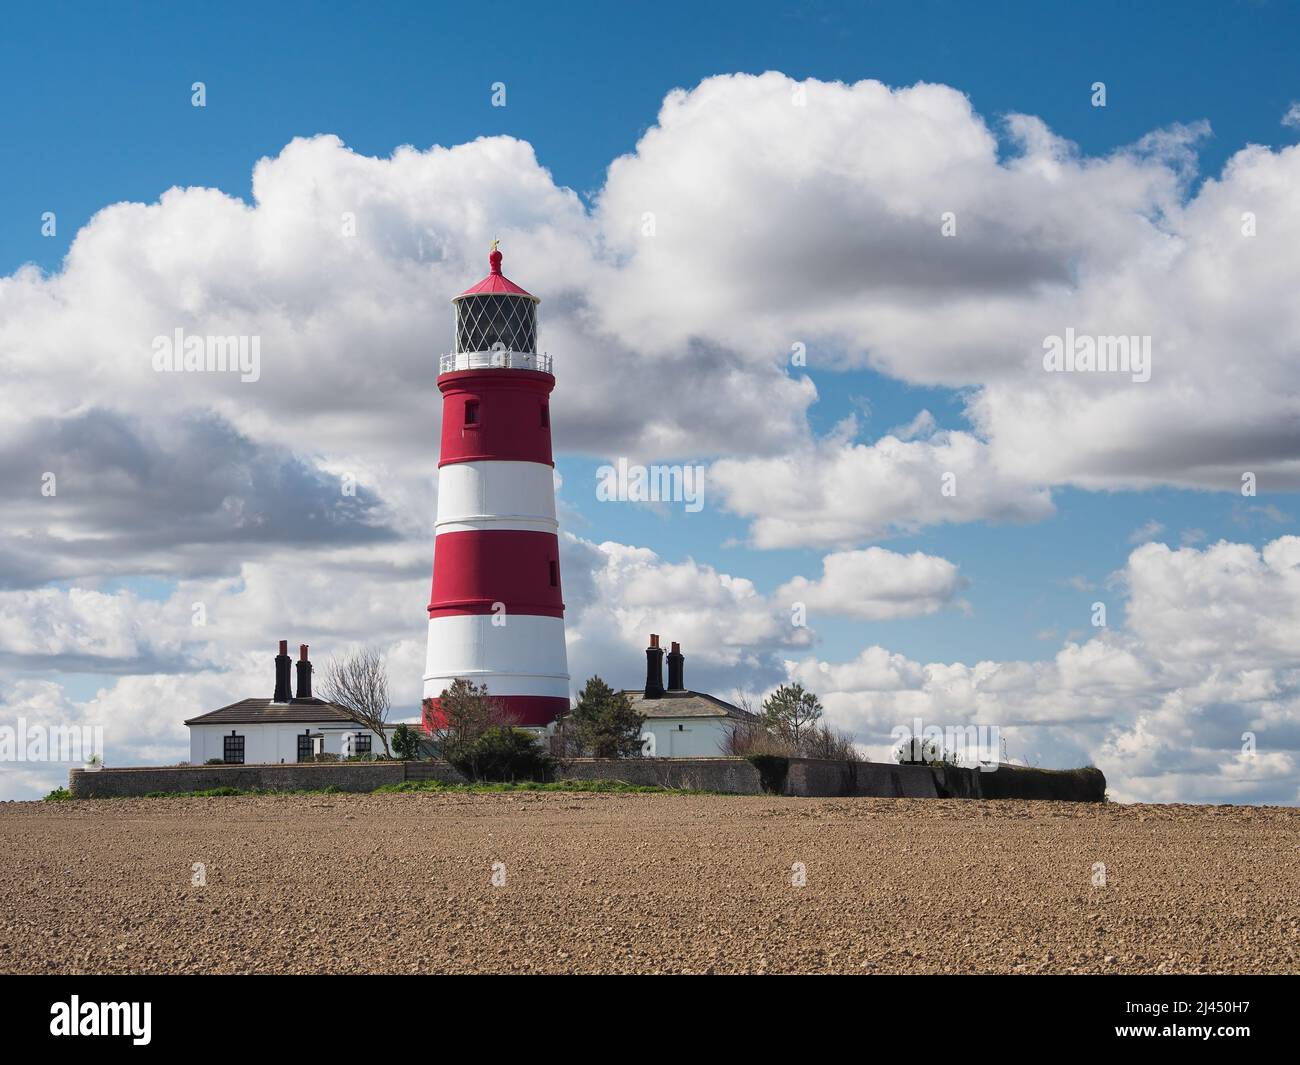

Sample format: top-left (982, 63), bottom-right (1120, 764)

top-left (424, 241), bottom-right (569, 728)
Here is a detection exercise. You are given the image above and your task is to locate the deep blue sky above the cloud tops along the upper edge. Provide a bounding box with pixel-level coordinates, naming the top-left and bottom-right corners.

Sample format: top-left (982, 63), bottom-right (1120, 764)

top-left (0, 0), bottom-right (1300, 270)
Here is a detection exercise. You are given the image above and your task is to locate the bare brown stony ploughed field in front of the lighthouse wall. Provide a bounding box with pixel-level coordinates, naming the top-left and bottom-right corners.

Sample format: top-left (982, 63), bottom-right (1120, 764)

top-left (0, 793), bottom-right (1300, 973)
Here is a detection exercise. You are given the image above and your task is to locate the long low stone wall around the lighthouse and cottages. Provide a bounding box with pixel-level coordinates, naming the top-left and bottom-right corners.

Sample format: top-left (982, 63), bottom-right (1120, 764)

top-left (68, 758), bottom-right (1106, 802)
